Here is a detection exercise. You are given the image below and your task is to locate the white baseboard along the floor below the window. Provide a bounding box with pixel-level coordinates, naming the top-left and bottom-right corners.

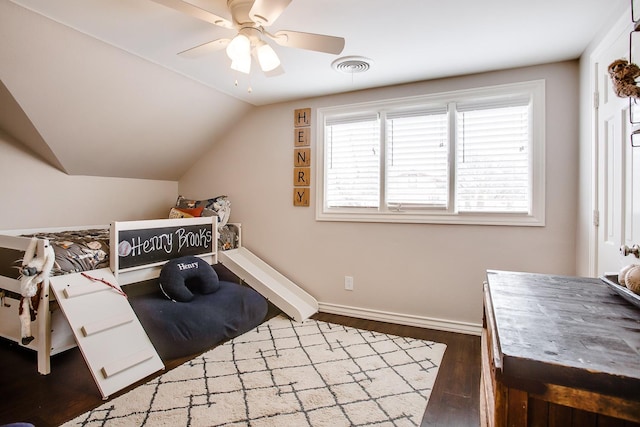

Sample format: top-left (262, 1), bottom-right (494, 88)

top-left (318, 302), bottom-right (482, 336)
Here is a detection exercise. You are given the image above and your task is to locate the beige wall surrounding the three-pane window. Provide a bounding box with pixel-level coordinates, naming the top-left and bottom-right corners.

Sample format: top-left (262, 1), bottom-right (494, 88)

top-left (179, 61), bottom-right (579, 329)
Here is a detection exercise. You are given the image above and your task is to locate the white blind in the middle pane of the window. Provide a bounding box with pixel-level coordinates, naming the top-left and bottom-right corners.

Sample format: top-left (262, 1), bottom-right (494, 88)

top-left (386, 108), bottom-right (449, 209)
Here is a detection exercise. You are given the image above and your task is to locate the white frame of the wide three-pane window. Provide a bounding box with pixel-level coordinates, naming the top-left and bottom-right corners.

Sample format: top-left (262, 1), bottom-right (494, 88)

top-left (315, 80), bottom-right (546, 226)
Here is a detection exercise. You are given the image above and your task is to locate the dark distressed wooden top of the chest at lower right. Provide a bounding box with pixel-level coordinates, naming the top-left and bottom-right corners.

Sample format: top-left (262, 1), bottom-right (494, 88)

top-left (485, 270), bottom-right (640, 401)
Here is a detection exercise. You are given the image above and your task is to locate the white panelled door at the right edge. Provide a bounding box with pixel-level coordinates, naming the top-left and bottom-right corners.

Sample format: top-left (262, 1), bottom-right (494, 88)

top-left (595, 26), bottom-right (640, 275)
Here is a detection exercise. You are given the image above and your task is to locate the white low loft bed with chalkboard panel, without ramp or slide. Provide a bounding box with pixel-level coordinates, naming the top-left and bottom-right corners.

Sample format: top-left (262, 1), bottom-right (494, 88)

top-left (0, 217), bottom-right (218, 375)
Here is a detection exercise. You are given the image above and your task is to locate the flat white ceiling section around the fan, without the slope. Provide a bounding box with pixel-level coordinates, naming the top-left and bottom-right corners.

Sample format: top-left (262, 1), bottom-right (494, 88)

top-left (5, 0), bottom-right (628, 105)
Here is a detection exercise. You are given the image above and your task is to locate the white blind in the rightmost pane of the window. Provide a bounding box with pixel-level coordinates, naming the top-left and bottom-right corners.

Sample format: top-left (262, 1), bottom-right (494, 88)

top-left (456, 105), bottom-right (531, 213)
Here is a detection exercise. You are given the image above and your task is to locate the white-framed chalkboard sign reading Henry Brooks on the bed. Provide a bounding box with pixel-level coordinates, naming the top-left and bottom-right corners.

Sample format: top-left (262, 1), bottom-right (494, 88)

top-left (118, 223), bottom-right (216, 268)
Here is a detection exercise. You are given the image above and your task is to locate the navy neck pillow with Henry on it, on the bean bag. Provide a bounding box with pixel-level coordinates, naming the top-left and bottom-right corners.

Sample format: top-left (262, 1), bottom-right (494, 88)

top-left (159, 256), bottom-right (220, 302)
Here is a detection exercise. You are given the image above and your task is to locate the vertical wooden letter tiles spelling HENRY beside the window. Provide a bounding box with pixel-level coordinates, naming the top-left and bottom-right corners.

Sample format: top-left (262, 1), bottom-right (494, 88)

top-left (293, 108), bottom-right (311, 206)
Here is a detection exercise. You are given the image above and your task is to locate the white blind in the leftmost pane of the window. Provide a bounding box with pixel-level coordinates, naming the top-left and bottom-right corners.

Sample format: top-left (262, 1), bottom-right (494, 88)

top-left (325, 115), bottom-right (380, 208)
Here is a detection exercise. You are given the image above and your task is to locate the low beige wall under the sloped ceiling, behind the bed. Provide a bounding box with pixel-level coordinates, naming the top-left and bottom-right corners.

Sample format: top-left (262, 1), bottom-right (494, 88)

top-left (0, 132), bottom-right (178, 230)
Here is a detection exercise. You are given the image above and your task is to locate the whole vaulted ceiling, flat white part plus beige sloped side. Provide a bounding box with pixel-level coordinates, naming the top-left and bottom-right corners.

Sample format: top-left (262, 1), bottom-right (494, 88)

top-left (0, 0), bottom-right (628, 180)
